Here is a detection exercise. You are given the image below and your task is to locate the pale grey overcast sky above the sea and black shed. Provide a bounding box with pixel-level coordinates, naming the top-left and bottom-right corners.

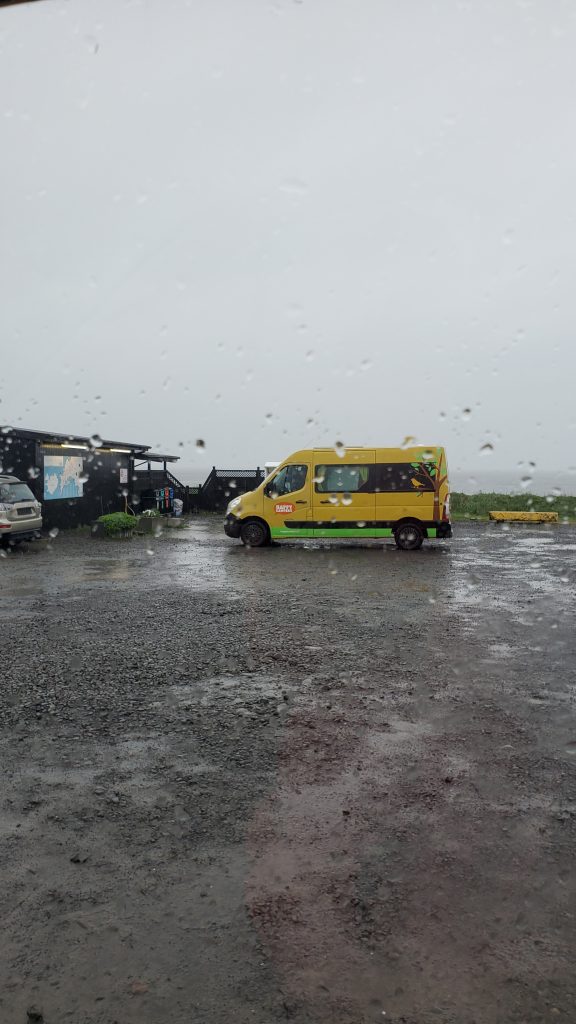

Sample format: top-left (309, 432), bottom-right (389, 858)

top-left (0, 0), bottom-right (576, 487)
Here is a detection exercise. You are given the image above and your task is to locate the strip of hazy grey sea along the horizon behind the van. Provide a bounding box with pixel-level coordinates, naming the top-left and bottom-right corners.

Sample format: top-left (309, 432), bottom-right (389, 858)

top-left (171, 463), bottom-right (576, 496)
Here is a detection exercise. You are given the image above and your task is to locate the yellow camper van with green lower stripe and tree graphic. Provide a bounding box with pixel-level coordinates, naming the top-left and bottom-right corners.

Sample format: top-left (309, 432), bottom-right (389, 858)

top-left (224, 446), bottom-right (452, 551)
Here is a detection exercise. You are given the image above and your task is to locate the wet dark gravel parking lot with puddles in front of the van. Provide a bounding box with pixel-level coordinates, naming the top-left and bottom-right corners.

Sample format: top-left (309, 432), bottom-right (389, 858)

top-left (0, 519), bottom-right (576, 1024)
